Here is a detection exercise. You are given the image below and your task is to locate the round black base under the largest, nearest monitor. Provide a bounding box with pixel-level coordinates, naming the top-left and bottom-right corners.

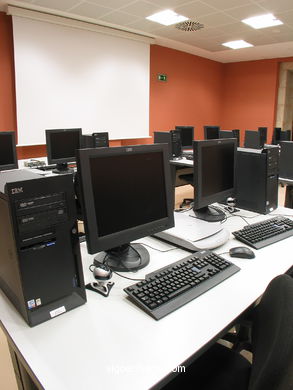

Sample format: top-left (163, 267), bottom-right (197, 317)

top-left (94, 244), bottom-right (150, 272)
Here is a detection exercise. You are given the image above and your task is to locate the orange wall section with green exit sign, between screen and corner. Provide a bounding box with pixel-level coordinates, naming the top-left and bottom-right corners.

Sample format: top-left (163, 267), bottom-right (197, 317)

top-left (150, 45), bottom-right (224, 139)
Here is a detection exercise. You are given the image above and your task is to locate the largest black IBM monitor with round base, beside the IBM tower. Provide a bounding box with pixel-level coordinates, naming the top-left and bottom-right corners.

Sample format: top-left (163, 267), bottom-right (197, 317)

top-left (77, 144), bottom-right (174, 271)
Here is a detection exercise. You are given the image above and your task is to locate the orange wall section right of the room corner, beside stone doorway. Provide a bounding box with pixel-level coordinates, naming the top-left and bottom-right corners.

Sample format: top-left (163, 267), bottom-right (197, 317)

top-left (221, 60), bottom-right (279, 140)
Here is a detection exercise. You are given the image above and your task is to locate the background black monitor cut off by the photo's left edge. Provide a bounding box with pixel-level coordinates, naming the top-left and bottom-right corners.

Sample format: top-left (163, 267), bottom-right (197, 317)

top-left (0, 131), bottom-right (18, 171)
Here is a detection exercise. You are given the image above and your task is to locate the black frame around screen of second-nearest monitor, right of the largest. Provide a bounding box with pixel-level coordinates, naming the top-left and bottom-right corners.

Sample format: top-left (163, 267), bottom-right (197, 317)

top-left (193, 138), bottom-right (237, 210)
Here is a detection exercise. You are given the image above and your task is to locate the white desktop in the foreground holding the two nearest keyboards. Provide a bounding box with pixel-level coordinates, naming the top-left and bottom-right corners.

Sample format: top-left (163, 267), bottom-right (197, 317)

top-left (0, 209), bottom-right (293, 390)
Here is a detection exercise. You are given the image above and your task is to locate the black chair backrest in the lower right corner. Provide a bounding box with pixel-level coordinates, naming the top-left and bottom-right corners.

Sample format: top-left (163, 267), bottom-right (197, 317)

top-left (249, 274), bottom-right (293, 390)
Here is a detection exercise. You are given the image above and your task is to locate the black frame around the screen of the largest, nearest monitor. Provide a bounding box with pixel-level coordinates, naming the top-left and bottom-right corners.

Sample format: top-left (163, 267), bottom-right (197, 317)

top-left (76, 144), bottom-right (174, 254)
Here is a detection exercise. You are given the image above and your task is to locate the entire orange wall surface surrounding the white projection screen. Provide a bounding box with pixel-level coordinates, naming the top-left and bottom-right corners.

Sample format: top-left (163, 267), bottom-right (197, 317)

top-left (0, 12), bottom-right (293, 158)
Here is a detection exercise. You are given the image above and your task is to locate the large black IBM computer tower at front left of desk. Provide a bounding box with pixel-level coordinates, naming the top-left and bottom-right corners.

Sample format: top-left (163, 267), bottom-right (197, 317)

top-left (0, 170), bottom-right (86, 326)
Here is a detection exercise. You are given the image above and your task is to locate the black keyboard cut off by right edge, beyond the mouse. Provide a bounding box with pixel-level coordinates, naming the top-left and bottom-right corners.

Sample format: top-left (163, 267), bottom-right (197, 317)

top-left (233, 216), bottom-right (293, 249)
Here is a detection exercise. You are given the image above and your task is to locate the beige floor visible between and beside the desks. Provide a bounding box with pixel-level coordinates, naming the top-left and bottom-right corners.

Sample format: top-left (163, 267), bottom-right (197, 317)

top-left (0, 186), bottom-right (285, 390)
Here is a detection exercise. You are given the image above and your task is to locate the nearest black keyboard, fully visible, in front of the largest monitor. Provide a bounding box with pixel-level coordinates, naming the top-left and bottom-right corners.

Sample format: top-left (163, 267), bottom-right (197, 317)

top-left (124, 250), bottom-right (240, 320)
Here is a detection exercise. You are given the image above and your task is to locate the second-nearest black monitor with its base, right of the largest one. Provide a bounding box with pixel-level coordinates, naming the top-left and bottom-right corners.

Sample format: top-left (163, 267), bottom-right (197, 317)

top-left (193, 138), bottom-right (237, 222)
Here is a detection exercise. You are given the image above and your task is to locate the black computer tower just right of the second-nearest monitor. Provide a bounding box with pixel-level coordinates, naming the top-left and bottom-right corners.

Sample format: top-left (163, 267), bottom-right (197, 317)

top-left (236, 147), bottom-right (279, 214)
